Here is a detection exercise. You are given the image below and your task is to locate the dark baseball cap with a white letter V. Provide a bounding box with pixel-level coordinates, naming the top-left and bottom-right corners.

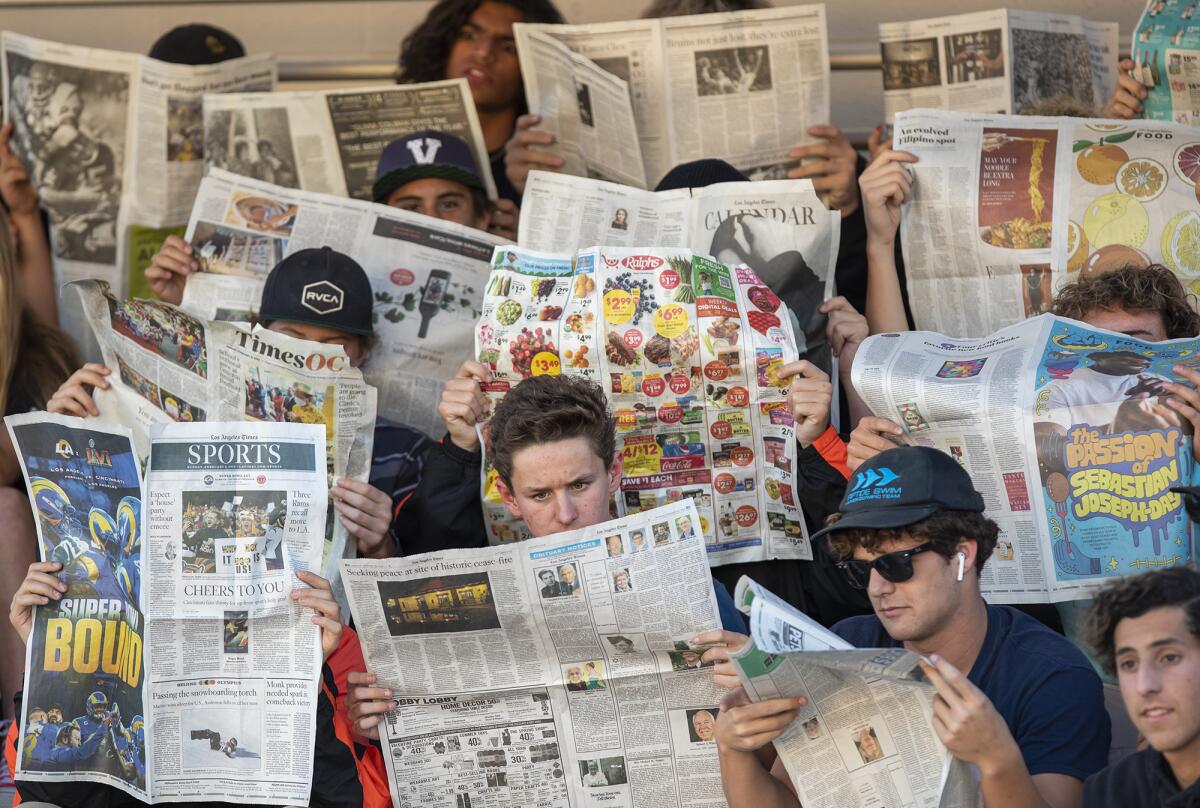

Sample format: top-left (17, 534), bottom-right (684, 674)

top-left (371, 130), bottom-right (484, 202)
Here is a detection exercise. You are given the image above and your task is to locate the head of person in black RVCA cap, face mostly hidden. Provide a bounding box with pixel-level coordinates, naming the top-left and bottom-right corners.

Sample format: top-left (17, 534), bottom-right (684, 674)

top-left (258, 247), bottom-right (374, 367)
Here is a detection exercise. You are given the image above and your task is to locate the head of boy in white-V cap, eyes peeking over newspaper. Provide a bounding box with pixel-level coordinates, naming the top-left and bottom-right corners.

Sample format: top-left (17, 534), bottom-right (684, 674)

top-left (372, 130), bottom-right (492, 231)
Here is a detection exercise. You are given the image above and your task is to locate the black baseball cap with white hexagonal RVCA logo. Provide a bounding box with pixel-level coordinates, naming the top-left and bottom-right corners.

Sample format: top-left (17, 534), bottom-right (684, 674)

top-left (258, 247), bottom-right (374, 336)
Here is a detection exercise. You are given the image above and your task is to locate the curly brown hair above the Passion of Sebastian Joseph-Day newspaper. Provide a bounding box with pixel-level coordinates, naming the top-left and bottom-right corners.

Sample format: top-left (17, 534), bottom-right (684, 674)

top-left (1051, 264), bottom-right (1200, 340)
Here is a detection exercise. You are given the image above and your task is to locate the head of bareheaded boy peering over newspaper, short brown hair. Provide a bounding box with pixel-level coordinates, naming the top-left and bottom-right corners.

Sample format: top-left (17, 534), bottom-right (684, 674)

top-left (487, 376), bottom-right (622, 537)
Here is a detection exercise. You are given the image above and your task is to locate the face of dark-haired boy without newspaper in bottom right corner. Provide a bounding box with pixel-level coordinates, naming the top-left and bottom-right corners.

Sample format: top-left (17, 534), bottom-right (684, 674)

top-left (1112, 606), bottom-right (1200, 767)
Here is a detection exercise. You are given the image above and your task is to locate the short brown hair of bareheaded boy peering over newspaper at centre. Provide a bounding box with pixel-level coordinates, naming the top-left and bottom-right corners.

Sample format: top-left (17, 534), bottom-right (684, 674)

top-left (487, 376), bottom-right (617, 487)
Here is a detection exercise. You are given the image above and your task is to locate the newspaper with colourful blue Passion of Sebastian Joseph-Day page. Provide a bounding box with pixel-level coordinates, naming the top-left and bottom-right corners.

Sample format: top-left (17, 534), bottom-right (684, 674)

top-left (853, 315), bottom-right (1200, 603)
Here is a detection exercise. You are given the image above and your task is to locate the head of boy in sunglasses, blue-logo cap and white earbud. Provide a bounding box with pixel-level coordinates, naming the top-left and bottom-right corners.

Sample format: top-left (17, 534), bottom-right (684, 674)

top-left (812, 447), bottom-right (1000, 647)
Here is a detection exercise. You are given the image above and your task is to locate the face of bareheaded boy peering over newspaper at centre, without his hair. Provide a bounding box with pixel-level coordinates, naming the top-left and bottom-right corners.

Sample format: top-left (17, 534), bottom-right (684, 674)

top-left (499, 437), bottom-right (622, 538)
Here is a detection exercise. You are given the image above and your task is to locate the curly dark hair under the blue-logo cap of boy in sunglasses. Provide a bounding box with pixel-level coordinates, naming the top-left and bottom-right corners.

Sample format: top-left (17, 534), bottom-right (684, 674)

top-left (826, 510), bottom-right (1000, 574)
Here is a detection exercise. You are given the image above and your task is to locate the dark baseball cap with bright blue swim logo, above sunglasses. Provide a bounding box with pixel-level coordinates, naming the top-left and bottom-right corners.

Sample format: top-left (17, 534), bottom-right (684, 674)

top-left (812, 447), bottom-right (983, 539)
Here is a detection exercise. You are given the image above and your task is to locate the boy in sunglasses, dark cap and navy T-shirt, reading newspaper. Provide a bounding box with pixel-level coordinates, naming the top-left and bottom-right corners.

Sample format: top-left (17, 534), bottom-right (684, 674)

top-left (716, 447), bottom-right (1111, 808)
